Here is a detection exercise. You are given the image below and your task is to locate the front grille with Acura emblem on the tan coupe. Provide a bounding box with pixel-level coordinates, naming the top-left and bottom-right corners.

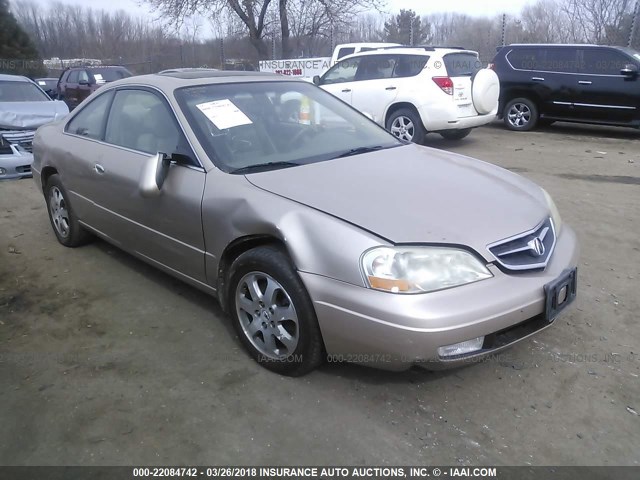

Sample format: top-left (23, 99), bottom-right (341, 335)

top-left (488, 218), bottom-right (556, 271)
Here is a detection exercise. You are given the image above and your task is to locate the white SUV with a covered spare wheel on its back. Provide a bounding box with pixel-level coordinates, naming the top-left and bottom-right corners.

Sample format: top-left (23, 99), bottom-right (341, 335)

top-left (314, 47), bottom-right (500, 143)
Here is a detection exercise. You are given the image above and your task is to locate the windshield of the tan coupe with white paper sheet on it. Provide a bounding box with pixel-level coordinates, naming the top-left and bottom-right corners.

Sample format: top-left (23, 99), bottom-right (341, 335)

top-left (175, 81), bottom-right (403, 173)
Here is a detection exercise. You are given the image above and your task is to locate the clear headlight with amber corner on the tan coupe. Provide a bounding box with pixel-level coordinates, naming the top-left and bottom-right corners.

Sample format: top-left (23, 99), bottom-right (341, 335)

top-left (362, 247), bottom-right (493, 293)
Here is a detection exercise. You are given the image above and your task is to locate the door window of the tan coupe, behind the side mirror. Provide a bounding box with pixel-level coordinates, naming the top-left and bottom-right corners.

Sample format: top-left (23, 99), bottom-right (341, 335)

top-left (104, 90), bottom-right (189, 155)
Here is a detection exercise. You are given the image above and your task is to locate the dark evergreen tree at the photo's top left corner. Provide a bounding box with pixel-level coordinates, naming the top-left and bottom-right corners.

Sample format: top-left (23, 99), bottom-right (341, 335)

top-left (0, 0), bottom-right (44, 77)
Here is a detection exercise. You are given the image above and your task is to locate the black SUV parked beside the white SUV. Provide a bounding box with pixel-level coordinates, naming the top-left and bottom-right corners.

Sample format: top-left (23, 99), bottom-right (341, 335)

top-left (491, 44), bottom-right (640, 131)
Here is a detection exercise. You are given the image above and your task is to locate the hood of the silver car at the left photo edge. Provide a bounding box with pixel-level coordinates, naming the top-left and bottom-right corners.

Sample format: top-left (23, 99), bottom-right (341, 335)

top-left (0, 100), bottom-right (69, 130)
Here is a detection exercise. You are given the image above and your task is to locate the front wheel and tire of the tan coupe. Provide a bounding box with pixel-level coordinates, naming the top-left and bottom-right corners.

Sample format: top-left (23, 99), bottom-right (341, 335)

top-left (227, 246), bottom-right (324, 377)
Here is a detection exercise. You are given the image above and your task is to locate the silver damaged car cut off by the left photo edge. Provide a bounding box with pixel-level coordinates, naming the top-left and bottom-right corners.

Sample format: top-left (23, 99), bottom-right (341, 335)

top-left (0, 74), bottom-right (69, 180)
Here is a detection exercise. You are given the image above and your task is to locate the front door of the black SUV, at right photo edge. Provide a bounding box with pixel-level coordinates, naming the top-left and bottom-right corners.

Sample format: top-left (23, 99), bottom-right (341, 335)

top-left (575, 47), bottom-right (640, 123)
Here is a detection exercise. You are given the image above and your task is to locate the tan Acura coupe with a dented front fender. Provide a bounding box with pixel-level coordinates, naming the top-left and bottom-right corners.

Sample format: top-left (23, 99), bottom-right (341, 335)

top-left (34, 71), bottom-right (577, 375)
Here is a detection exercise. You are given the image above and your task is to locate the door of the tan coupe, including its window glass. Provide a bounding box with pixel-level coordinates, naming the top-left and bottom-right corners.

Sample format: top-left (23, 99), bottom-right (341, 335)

top-left (89, 88), bottom-right (206, 282)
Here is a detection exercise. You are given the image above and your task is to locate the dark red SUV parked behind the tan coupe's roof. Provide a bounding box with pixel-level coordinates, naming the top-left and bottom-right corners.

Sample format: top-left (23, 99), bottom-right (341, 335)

top-left (58, 65), bottom-right (132, 110)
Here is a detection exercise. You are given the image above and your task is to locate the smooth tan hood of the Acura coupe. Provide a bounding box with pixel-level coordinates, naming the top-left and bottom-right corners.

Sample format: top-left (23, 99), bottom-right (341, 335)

top-left (247, 145), bottom-right (549, 256)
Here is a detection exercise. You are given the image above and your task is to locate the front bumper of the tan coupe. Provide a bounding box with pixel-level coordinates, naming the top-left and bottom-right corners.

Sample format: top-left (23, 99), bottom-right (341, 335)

top-left (300, 225), bottom-right (578, 370)
